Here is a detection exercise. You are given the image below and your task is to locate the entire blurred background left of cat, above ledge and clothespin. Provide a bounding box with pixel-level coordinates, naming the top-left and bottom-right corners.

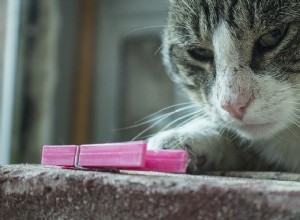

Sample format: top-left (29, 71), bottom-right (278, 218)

top-left (0, 0), bottom-right (185, 164)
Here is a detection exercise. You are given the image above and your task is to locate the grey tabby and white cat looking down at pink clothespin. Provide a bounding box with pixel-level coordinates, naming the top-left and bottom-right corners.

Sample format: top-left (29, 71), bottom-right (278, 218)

top-left (148, 0), bottom-right (300, 173)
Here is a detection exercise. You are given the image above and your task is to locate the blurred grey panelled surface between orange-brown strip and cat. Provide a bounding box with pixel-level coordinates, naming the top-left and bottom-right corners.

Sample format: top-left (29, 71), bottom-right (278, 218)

top-left (93, 0), bottom-right (184, 142)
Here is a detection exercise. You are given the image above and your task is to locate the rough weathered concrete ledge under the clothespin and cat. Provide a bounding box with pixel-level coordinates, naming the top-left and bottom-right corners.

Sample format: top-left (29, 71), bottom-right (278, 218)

top-left (0, 165), bottom-right (300, 220)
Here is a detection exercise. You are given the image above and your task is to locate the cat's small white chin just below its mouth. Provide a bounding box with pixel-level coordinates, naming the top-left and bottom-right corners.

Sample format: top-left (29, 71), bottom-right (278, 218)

top-left (235, 122), bottom-right (282, 140)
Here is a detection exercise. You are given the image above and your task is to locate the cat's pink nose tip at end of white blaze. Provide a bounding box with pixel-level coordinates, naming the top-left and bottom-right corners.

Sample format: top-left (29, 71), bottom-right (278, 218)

top-left (221, 100), bottom-right (249, 120)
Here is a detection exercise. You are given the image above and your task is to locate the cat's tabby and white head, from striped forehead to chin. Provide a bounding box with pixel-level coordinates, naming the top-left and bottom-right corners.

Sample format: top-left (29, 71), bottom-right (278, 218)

top-left (163, 0), bottom-right (300, 139)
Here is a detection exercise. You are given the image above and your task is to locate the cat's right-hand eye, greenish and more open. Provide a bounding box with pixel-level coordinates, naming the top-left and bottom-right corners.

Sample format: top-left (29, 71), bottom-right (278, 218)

top-left (258, 27), bottom-right (286, 48)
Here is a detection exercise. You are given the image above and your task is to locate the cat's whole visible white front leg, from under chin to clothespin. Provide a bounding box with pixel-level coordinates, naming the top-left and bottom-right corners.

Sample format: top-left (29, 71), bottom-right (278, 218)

top-left (148, 119), bottom-right (243, 173)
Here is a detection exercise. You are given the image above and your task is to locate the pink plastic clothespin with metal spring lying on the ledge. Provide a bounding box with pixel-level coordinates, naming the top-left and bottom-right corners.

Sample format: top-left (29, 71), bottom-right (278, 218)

top-left (41, 141), bottom-right (187, 173)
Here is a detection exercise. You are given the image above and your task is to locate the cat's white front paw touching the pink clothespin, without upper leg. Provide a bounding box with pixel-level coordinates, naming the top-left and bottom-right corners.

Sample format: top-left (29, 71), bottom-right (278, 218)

top-left (148, 130), bottom-right (223, 173)
